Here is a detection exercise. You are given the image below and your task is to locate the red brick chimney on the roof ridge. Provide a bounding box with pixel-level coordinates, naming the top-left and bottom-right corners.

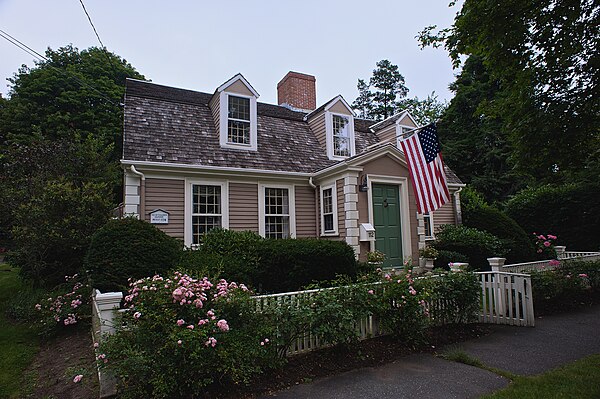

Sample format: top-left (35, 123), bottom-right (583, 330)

top-left (277, 71), bottom-right (317, 111)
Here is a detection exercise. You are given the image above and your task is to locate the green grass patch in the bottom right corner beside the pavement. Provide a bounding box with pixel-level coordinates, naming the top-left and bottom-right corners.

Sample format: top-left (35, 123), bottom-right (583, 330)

top-left (483, 354), bottom-right (600, 399)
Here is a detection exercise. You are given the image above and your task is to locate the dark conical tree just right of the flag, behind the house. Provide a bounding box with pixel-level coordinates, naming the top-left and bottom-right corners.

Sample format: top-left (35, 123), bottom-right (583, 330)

top-left (438, 56), bottom-right (526, 202)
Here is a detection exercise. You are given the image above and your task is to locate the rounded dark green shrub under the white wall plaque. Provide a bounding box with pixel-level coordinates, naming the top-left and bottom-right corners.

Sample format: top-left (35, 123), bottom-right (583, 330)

top-left (85, 218), bottom-right (182, 291)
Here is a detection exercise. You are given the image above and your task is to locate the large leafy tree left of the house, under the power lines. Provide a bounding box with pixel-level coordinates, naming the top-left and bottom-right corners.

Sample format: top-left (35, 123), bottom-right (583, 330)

top-left (0, 45), bottom-right (144, 161)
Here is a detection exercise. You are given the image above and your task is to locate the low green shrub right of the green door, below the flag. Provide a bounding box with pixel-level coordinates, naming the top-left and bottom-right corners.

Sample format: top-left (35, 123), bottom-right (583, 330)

top-left (433, 225), bottom-right (507, 270)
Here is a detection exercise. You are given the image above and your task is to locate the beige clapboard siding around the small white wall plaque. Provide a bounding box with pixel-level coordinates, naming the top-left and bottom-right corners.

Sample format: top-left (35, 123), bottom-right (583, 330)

top-left (144, 179), bottom-right (185, 240)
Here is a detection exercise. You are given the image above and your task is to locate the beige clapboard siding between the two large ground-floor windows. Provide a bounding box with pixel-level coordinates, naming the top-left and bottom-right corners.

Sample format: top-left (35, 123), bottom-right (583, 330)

top-left (229, 183), bottom-right (258, 233)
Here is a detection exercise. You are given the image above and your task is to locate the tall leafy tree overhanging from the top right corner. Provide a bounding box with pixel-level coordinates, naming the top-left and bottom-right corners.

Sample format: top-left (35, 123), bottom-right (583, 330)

top-left (420, 0), bottom-right (600, 181)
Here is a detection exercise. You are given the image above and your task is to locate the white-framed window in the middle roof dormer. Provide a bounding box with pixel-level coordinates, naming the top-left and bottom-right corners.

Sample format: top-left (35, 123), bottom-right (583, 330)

top-left (325, 111), bottom-right (356, 160)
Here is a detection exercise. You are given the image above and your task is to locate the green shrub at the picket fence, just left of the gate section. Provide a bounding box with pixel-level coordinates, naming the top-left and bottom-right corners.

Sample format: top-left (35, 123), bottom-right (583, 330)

top-left (417, 271), bottom-right (481, 325)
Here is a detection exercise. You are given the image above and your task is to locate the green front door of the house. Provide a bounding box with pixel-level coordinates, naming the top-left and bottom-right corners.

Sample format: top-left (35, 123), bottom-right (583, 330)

top-left (372, 184), bottom-right (402, 267)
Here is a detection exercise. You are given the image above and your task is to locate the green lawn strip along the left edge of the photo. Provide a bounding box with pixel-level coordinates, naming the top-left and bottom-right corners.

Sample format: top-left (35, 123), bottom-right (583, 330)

top-left (0, 264), bottom-right (39, 398)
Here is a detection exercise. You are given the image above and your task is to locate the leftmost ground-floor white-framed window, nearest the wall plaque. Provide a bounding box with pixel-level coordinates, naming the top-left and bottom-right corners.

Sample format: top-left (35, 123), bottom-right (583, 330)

top-left (184, 179), bottom-right (229, 247)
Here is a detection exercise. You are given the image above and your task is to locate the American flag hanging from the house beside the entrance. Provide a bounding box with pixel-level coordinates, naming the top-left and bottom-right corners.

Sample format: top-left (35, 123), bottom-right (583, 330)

top-left (400, 124), bottom-right (450, 214)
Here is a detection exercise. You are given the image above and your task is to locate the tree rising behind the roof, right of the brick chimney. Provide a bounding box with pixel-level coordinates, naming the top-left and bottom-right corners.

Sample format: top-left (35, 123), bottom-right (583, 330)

top-left (352, 60), bottom-right (408, 120)
